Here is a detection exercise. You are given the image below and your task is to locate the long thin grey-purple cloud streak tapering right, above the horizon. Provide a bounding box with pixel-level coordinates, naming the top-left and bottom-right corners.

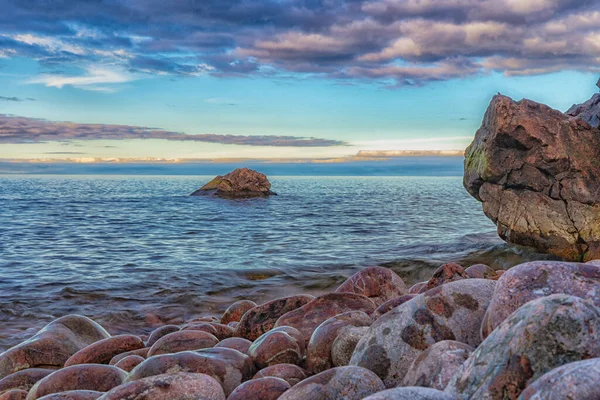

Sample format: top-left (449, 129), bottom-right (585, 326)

top-left (0, 114), bottom-right (347, 147)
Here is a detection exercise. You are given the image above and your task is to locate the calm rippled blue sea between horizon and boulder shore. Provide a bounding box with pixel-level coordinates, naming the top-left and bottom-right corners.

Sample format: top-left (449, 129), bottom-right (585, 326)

top-left (0, 175), bottom-right (552, 349)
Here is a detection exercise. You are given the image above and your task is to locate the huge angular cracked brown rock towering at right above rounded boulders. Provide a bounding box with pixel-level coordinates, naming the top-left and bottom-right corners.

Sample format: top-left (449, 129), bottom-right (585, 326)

top-left (463, 95), bottom-right (600, 261)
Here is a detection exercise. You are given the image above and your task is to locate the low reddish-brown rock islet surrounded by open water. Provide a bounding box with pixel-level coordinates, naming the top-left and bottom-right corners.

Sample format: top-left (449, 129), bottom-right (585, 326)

top-left (191, 168), bottom-right (277, 199)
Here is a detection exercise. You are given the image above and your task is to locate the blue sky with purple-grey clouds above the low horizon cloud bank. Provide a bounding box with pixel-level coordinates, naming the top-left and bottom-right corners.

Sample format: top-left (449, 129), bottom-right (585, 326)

top-left (0, 0), bottom-right (600, 160)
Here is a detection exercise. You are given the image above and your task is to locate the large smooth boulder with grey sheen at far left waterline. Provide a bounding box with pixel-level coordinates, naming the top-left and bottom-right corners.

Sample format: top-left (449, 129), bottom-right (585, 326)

top-left (0, 315), bottom-right (110, 379)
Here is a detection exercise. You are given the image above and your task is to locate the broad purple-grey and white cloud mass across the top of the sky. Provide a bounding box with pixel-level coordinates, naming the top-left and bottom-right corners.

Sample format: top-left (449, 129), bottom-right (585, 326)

top-left (0, 0), bottom-right (600, 86)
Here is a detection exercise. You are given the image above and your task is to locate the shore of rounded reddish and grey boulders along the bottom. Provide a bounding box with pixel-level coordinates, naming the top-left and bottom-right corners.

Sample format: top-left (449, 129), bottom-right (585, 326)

top-left (0, 261), bottom-right (600, 400)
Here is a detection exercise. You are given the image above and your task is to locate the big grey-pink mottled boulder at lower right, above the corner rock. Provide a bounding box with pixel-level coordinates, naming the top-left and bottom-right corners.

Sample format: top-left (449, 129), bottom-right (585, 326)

top-left (446, 294), bottom-right (600, 400)
